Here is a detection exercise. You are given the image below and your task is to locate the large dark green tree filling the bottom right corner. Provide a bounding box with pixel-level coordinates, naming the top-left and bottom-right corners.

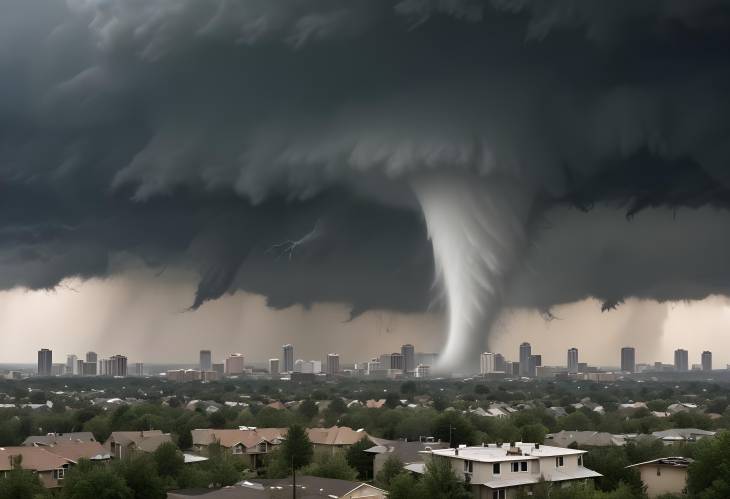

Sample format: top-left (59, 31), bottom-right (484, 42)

top-left (687, 431), bottom-right (730, 499)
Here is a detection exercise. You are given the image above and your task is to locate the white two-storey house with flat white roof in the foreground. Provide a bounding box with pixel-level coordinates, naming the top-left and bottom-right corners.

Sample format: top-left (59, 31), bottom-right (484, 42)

top-left (420, 442), bottom-right (601, 499)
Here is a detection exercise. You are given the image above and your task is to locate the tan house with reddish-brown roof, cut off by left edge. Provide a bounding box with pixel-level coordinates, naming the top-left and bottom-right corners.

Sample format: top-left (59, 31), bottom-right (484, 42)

top-left (0, 446), bottom-right (73, 489)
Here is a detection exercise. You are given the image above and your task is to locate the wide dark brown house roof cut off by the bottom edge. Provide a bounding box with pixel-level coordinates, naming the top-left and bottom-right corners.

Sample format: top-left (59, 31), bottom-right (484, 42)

top-left (167, 476), bottom-right (388, 499)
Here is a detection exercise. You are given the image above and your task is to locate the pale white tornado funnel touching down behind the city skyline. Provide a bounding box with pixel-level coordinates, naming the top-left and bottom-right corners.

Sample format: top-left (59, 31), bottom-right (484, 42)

top-left (412, 175), bottom-right (530, 374)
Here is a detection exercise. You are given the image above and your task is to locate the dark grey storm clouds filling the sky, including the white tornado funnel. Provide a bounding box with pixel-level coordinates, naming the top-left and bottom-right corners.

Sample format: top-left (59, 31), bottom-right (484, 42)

top-left (0, 0), bottom-right (730, 372)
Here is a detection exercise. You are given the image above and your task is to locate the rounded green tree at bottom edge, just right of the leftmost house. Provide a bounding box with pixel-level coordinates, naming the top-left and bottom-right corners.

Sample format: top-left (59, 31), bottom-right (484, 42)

top-left (61, 459), bottom-right (134, 499)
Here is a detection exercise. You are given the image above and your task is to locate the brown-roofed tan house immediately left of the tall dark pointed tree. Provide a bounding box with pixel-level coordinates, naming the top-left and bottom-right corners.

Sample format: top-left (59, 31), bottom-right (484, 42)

top-left (191, 427), bottom-right (287, 469)
